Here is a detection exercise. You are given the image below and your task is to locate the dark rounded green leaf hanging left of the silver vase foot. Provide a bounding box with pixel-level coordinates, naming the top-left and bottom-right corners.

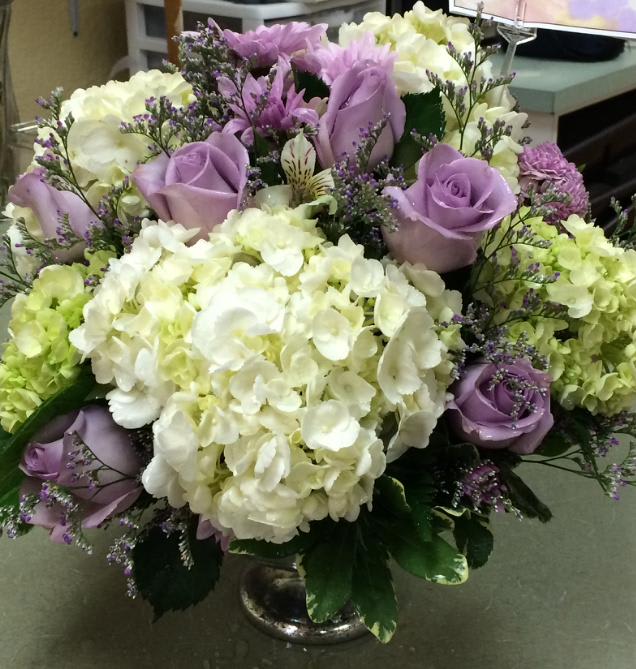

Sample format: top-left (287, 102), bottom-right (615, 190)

top-left (133, 520), bottom-right (223, 621)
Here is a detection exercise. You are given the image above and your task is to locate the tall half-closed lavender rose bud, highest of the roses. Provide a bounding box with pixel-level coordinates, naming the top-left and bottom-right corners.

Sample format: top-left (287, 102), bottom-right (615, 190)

top-left (316, 62), bottom-right (406, 168)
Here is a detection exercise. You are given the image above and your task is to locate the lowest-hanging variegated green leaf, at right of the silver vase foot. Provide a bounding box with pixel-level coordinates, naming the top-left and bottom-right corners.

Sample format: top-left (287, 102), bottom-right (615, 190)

top-left (351, 525), bottom-right (397, 643)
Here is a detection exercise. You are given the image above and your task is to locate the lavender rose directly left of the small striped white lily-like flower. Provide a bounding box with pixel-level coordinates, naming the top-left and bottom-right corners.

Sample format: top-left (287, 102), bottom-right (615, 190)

top-left (133, 132), bottom-right (249, 239)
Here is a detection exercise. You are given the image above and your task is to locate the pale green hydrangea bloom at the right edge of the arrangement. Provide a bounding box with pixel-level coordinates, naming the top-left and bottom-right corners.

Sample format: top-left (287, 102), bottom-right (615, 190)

top-left (484, 212), bottom-right (636, 416)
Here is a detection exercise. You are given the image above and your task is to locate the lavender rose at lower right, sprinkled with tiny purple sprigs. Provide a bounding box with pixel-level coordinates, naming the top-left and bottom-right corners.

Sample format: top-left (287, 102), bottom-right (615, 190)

top-left (448, 360), bottom-right (554, 454)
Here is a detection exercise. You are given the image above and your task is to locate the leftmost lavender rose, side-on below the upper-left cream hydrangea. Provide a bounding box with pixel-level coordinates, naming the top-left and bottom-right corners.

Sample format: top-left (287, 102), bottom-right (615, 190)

top-left (9, 168), bottom-right (97, 262)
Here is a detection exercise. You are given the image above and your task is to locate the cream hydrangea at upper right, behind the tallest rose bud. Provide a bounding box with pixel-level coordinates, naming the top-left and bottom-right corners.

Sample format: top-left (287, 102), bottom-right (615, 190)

top-left (340, 2), bottom-right (527, 191)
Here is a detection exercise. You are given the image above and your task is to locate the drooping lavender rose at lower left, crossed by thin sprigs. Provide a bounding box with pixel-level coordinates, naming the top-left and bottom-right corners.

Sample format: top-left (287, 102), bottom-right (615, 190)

top-left (20, 405), bottom-right (142, 543)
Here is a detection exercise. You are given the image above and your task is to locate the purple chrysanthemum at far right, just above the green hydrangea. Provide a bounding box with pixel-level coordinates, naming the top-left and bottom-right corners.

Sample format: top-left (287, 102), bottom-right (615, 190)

top-left (519, 142), bottom-right (590, 223)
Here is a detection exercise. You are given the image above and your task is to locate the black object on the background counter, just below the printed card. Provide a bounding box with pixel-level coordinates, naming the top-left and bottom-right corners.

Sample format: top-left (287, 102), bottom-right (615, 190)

top-left (517, 30), bottom-right (625, 62)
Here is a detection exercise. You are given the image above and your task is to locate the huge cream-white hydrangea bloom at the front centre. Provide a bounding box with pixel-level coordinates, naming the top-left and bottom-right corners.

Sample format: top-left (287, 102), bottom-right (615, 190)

top-left (70, 207), bottom-right (461, 542)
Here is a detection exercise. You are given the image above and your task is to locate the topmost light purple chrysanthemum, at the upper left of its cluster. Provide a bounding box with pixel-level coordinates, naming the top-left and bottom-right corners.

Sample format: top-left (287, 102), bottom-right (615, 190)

top-left (223, 21), bottom-right (327, 67)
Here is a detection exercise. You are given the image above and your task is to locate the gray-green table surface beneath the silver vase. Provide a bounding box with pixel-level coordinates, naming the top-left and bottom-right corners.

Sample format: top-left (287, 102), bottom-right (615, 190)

top-left (0, 456), bottom-right (636, 669)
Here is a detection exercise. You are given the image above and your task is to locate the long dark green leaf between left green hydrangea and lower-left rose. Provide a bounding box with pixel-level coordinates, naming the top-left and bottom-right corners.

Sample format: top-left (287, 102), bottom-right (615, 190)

top-left (0, 366), bottom-right (95, 497)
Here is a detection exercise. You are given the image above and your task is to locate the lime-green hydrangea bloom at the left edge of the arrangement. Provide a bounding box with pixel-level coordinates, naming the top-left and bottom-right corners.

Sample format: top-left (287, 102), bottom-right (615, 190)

top-left (0, 251), bottom-right (113, 432)
